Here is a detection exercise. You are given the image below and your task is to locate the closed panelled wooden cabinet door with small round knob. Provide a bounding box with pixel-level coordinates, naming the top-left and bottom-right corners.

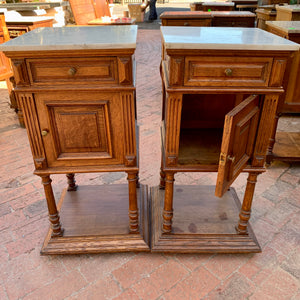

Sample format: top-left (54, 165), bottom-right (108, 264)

top-left (35, 92), bottom-right (124, 168)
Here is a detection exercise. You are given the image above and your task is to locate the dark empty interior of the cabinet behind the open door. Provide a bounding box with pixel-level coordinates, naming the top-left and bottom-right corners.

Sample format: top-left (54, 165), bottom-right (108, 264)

top-left (178, 94), bottom-right (239, 165)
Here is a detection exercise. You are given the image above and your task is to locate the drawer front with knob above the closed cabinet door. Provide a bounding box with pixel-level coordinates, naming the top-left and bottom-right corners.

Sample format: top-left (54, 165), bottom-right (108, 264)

top-left (27, 57), bottom-right (118, 85)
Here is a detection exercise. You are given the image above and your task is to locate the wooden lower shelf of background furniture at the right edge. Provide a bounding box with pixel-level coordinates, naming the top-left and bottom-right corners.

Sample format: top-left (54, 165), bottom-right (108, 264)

top-left (272, 131), bottom-right (300, 161)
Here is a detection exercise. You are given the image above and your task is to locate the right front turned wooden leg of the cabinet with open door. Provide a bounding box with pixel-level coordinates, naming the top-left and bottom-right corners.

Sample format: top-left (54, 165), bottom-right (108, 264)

top-left (236, 173), bottom-right (260, 234)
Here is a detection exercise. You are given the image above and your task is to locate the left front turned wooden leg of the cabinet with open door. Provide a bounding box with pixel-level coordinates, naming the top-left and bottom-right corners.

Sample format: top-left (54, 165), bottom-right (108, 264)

top-left (162, 172), bottom-right (174, 233)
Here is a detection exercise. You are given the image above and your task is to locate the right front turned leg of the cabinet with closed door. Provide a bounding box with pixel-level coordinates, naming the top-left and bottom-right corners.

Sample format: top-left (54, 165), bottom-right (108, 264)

top-left (127, 172), bottom-right (139, 233)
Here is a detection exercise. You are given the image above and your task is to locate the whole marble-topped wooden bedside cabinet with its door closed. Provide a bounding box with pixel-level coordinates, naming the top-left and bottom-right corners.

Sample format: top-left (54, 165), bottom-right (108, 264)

top-left (1, 26), bottom-right (150, 254)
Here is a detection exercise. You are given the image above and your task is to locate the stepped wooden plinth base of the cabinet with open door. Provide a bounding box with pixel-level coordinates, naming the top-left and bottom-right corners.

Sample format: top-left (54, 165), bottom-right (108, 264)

top-left (151, 185), bottom-right (261, 253)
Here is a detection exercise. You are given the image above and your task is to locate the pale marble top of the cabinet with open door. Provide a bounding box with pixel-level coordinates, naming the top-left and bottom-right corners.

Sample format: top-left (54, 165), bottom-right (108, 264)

top-left (161, 26), bottom-right (300, 51)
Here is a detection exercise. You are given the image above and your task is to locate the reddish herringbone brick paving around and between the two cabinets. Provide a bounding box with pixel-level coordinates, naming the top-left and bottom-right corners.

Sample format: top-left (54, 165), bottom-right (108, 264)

top-left (0, 4), bottom-right (300, 300)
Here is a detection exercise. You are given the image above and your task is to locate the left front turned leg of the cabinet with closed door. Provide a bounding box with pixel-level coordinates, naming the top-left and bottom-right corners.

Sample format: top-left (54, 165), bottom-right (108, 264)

top-left (42, 175), bottom-right (63, 237)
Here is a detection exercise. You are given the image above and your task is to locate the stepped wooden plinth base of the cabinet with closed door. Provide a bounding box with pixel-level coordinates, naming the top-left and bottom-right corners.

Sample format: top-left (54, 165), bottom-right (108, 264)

top-left (41, 184), bottom-right (150, 254)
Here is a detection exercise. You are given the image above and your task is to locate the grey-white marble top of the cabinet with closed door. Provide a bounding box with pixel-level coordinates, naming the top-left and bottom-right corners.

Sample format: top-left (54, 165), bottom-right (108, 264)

top-left (0, 25), bottom-right (137, 51)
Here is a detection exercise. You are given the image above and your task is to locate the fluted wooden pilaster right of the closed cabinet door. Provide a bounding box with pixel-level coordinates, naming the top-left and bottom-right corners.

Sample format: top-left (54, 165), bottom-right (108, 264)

top-left (121, 93), bottom-right (137, 166)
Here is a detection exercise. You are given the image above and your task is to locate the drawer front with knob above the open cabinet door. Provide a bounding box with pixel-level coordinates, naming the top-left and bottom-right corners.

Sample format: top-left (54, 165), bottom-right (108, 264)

top-left (184, 56), bottom-right (273, 87)
